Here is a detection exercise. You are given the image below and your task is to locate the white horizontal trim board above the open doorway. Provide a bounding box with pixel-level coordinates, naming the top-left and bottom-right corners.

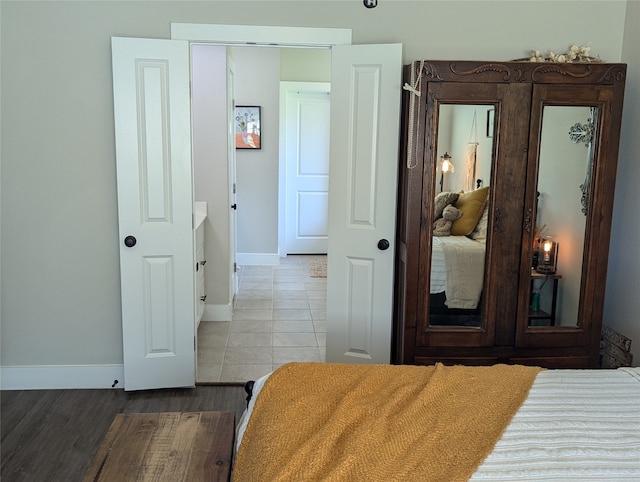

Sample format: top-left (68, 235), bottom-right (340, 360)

top-left (171, 23), bottom-right (352, 48)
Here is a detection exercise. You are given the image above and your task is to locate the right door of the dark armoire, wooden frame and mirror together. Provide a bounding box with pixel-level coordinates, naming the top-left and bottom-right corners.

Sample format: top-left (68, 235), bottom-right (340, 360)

top-left (517, 86), bottom-right (610, 347)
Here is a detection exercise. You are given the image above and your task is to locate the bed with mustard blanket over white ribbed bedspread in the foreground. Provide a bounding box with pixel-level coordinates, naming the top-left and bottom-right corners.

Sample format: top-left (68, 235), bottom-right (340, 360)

top-left (233, 363), bottom-right (640, 482)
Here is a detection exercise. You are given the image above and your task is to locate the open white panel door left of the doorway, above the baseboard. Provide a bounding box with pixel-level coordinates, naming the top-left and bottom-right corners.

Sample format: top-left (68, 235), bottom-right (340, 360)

top-left (112, 38), bottom-right (195, 390)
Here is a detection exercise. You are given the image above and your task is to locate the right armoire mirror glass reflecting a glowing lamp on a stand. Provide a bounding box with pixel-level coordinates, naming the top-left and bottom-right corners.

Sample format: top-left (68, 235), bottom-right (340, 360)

top-left (527, 105), bottom-right (598, 328)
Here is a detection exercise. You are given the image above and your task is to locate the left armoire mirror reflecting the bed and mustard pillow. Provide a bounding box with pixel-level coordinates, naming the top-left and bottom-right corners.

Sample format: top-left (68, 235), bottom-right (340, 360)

top-left (429, 104), bottom-right (495, 328)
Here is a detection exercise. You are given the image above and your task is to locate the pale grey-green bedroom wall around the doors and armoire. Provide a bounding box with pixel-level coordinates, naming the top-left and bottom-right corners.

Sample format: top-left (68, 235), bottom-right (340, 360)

top-left (0, 0), bottom-right (640, 386)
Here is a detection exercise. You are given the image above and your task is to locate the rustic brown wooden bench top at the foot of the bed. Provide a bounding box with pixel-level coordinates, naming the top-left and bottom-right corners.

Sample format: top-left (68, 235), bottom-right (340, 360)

top-left (84, 412), bottom-right (235, 482)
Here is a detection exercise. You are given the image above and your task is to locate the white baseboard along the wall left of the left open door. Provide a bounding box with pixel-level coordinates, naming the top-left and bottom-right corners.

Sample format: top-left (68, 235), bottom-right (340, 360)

top-left (0, 365), bottom-right (124, 390)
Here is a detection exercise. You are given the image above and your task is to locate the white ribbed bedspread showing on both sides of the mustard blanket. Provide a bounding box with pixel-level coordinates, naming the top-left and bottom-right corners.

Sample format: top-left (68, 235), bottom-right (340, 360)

top-left (236, 368), bottom-right (640, 482)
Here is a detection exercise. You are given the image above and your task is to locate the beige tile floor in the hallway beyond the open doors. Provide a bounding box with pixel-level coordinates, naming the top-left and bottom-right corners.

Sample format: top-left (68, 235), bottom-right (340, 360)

top-left (197, 255), bottom-right (327, 383)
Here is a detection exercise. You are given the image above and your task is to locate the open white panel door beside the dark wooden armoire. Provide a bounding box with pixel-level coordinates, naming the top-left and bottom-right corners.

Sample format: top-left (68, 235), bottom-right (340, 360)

top-left (327, 44), bottom-right (402, 363)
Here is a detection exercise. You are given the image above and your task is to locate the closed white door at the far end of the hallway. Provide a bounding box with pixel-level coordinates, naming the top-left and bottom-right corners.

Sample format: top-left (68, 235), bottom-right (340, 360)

top-left (285, 83), bottom-right (331, 254)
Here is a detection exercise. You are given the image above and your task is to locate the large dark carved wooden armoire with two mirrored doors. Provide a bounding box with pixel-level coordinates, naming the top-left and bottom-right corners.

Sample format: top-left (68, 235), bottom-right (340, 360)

top-left (392, 61), bottom-right (626, 368)
